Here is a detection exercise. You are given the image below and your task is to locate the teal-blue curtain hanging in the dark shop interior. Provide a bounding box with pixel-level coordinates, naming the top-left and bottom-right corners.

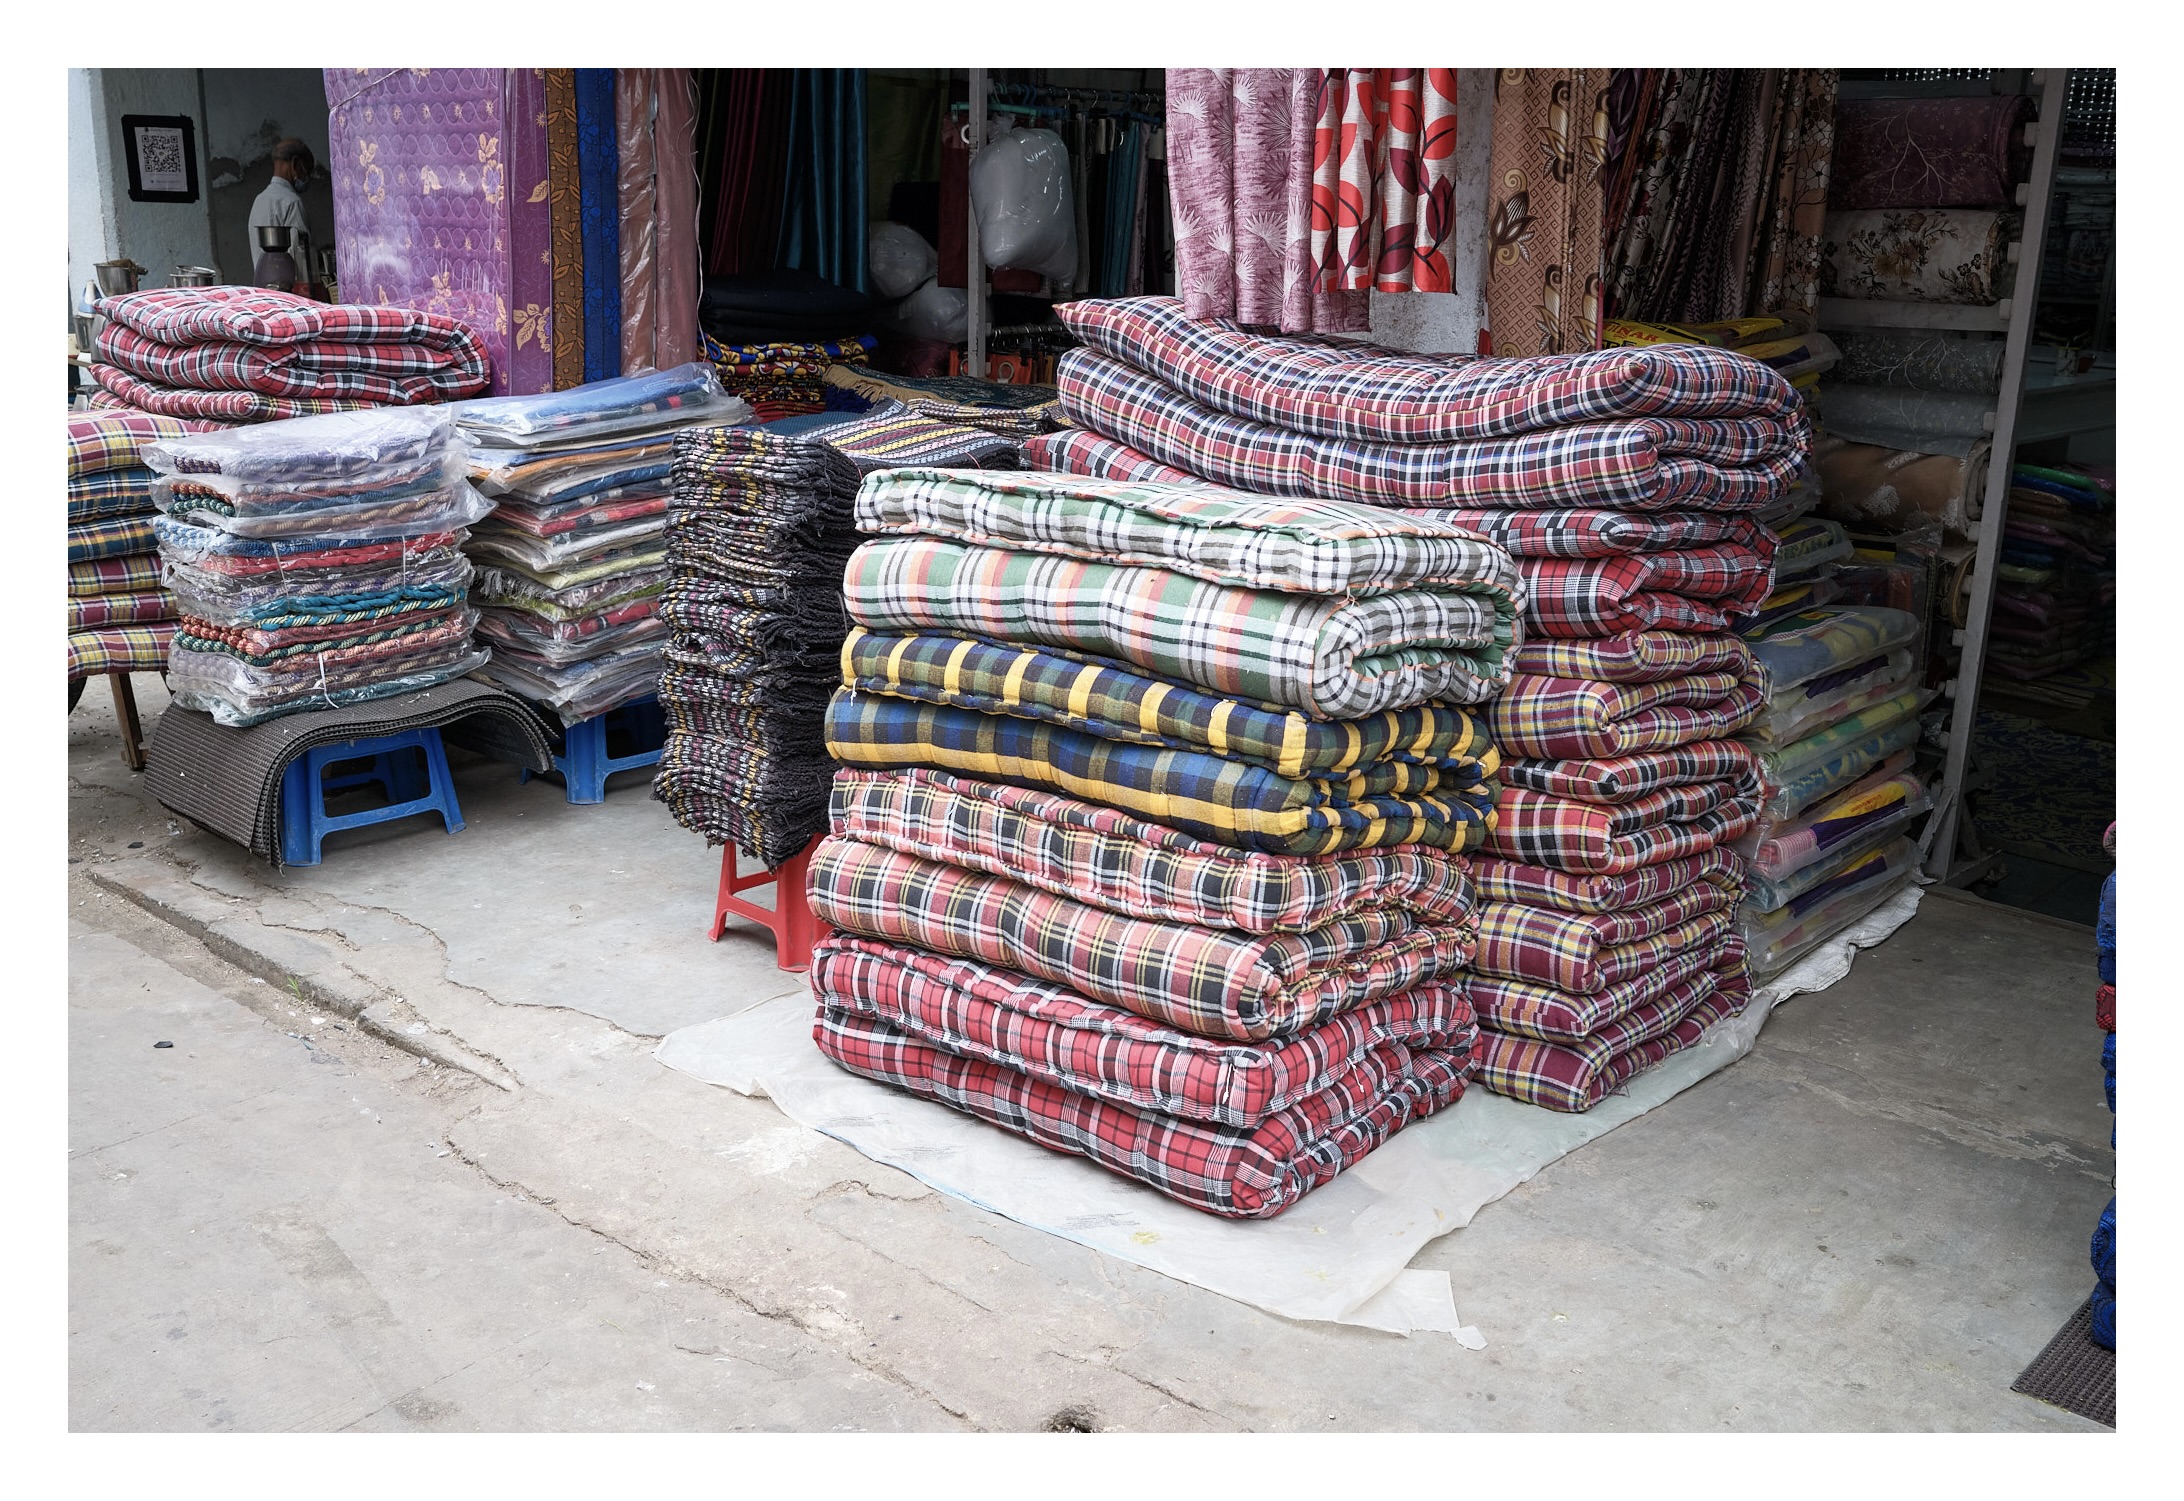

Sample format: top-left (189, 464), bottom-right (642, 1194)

top-left (775, 68), bottom-right (865, 291)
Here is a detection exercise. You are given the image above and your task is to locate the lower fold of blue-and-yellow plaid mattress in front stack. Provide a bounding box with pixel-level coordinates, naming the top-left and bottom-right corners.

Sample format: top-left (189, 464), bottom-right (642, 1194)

top-left (826, 688), bottom-right (1494, 854)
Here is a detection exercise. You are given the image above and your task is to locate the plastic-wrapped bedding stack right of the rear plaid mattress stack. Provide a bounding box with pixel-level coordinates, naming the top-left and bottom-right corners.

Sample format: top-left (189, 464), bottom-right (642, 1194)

top-left (1741, 605), bottom-right (1931, 979)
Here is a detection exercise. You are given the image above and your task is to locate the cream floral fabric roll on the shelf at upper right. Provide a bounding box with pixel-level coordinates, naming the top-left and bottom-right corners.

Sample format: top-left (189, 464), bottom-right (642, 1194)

top-left (1819, 208), bottom-right (2018, 306)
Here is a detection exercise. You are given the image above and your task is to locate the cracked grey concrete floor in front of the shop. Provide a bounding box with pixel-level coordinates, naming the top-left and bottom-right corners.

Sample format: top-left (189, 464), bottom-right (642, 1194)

top-left (70, 677), bottom-right (2114, 1431)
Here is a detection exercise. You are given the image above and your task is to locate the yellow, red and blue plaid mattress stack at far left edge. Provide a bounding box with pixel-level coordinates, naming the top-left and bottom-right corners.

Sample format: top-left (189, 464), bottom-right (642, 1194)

top-left (68, 411), bottom-right (188, 682)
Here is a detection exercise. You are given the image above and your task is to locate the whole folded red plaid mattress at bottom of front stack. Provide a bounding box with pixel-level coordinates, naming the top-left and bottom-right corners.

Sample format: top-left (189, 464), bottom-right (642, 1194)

top-left (810, 937), bottom-right (1476, 1219)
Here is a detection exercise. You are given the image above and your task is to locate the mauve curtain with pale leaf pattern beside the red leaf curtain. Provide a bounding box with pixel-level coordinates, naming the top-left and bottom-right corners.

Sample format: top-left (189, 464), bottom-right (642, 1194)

top-left (1161, 68), bottom-right (1367, 332)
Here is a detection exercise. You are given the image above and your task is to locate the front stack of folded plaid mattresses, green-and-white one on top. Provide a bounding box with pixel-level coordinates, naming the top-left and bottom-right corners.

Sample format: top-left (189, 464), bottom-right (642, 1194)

top-left (810, 470), bottom-right (1518, 1217)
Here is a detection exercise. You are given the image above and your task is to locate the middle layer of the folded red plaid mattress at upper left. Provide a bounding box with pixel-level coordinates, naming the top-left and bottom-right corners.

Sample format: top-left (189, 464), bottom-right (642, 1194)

top-left (98, 323), bottom-right (487, 406)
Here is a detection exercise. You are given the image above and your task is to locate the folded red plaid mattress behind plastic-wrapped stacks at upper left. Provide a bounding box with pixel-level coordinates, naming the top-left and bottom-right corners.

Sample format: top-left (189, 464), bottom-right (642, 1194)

top-left (92, 286), bottom-right (489, 422)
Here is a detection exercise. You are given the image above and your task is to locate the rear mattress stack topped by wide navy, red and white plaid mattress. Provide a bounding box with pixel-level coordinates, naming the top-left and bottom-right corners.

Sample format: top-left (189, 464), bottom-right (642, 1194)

top-left (1024, 297), bottom-right (1808, 1110)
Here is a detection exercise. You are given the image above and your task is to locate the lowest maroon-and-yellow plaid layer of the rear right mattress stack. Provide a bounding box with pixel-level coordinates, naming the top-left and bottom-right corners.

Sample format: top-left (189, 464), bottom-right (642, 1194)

top-left (1479, 959), bottom-right (1752, 1112)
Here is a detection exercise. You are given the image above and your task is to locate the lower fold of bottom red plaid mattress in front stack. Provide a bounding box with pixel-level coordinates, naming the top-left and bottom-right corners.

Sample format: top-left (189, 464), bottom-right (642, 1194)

top-left (812, 991), bottom-right (1472, 1219)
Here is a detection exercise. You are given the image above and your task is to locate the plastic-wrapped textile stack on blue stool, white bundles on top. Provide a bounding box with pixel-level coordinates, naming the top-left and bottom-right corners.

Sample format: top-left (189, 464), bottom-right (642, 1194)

top-left (144, 406), bottom-right (491, 725)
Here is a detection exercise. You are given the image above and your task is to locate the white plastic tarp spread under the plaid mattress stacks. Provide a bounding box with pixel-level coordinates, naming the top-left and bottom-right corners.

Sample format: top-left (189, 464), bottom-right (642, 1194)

top-left (657, 887), bottom-right (1920, 1348)
